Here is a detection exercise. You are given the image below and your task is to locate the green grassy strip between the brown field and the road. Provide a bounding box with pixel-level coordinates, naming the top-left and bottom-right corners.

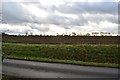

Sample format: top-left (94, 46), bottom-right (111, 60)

top-left (3, 43), bottom-right (120, 67)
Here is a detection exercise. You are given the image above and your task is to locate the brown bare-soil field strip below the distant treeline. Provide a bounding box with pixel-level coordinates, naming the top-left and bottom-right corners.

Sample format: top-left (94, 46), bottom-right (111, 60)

top-left (2, 35), bottom-right (120, 44)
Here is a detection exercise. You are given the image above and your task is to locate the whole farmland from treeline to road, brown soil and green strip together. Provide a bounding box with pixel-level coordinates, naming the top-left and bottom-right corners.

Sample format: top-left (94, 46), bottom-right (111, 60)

top-left (2, 35), bottom-right (120, 67)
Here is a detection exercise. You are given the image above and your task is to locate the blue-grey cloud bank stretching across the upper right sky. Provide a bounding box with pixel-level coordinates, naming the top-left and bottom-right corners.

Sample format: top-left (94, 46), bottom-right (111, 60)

top-left (57, 2), bottom-right (118, 14)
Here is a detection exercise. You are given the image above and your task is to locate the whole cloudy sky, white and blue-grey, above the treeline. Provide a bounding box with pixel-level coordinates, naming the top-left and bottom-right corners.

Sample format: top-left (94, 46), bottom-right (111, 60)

top-left (0, 0), bottom-right (118, 35)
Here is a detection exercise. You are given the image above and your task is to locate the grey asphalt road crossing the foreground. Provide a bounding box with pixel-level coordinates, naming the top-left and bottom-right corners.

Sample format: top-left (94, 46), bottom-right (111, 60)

top-left (2, 59), bottom-right (118, 78)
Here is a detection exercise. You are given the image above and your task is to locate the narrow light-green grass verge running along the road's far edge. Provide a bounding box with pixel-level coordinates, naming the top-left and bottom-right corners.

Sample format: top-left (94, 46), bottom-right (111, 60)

top-left (7, 56), bottom-right (120, 68)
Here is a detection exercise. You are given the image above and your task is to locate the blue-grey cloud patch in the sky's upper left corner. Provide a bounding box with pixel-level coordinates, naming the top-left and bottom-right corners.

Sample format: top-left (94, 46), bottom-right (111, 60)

top-left (2, 2), bottom-right (31, 24)
